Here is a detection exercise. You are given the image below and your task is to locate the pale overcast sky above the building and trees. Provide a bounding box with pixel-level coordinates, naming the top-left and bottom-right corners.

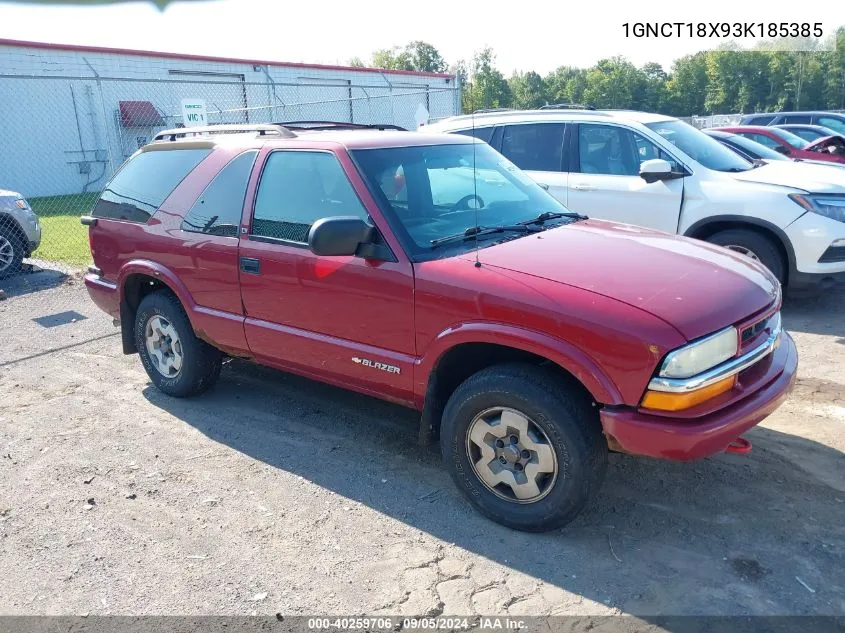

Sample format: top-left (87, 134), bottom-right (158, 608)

top-left (0, 0), bottom-right (845, 76)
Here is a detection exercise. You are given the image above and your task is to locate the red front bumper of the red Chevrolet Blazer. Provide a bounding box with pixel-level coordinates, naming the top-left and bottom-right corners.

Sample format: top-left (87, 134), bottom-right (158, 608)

top-left (601, 332), bottom-right (798, 461)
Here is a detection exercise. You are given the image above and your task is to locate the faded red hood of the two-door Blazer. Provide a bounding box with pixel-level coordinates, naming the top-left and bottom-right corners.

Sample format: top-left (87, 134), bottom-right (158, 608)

top-left (479, 220), bottom-right (779, 340)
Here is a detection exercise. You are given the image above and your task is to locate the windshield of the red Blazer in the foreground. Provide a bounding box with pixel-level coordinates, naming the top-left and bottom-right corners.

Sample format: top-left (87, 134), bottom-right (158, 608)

top-left (352, 143), bottom-right (571, 261)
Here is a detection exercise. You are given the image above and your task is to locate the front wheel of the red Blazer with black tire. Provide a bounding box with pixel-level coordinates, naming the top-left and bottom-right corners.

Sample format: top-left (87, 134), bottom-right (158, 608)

top-left (440, 364), bottom-right (608, 532)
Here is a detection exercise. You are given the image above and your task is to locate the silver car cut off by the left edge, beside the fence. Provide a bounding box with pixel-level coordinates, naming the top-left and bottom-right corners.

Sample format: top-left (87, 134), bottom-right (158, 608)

top-left (0, 189), bottom-right (41, 279)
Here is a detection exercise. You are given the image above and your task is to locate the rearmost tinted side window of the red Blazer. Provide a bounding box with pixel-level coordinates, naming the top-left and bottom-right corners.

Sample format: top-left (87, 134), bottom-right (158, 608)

top-left (91, 149), bottom-right (211, 222)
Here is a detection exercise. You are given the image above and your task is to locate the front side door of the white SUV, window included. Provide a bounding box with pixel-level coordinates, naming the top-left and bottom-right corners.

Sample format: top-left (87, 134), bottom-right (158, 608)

top-left (566, 123), bottom-right (684, 233)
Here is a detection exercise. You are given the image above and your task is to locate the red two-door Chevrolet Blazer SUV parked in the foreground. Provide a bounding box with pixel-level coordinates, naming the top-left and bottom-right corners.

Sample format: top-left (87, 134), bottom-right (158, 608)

top-left (83, 125), bottom-right (798, 531)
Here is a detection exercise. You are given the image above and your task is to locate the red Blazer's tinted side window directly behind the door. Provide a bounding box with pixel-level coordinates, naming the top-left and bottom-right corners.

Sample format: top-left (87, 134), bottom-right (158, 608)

top-left (182, 150), bottom-right (258, 237)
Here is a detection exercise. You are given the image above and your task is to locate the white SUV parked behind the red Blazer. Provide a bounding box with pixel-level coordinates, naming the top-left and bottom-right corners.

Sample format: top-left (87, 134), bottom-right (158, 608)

top-left (423, 110), bottom-right (845, 290)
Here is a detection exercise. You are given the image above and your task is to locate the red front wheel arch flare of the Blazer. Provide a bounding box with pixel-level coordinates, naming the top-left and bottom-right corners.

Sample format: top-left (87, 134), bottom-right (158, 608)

top-left (417, 324), bottom-right (623, 445)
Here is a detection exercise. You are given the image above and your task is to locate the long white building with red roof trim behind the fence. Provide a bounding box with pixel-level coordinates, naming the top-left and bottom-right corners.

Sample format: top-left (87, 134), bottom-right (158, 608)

top-left (0, 39), bottom-right (460, 197)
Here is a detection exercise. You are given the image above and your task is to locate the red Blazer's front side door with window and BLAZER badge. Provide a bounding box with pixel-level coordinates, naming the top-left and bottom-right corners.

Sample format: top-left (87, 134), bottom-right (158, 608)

top-left (239, 150), bottom-right (415, 404)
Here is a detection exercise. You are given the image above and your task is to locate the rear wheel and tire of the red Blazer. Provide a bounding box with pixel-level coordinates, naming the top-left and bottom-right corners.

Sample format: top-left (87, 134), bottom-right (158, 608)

top-left (135, 290), bottom-right (223, 398)
